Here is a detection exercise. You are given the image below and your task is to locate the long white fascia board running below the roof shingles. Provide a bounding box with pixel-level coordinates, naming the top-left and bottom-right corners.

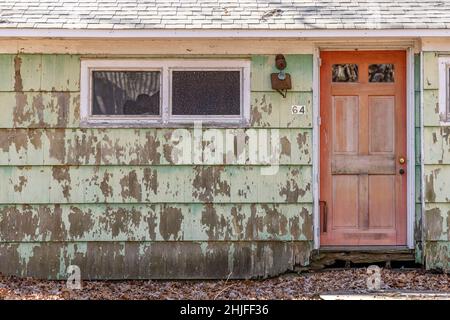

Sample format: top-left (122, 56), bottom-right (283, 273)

top-left (0, 28), bottom-right (450, 39)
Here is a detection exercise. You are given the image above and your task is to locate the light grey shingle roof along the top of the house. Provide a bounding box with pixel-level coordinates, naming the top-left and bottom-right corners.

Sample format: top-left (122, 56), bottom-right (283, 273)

top-left (0, 0), bottom-right (450, 30)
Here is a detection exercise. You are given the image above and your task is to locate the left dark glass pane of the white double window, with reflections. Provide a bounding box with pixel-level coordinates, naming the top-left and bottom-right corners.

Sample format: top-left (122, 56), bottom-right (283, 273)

top-left (92, 71), bottom-right (160, 115)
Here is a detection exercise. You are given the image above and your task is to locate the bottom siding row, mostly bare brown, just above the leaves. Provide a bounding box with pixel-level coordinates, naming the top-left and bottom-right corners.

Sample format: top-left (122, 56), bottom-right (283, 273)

top-left (0, 241), bottom-right (311, 279)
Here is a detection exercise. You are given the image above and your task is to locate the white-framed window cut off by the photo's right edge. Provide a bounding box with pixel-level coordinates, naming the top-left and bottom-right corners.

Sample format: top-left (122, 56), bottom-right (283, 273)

top-left (439, 57), bottom-right (450, 126)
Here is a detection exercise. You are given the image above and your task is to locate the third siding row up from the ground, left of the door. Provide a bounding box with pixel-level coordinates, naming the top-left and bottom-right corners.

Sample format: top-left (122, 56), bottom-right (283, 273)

top-left (0, 166), bottom-right (312, 204)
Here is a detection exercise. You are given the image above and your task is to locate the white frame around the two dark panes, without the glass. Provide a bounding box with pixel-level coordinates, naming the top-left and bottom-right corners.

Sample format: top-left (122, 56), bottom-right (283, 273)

top-left (80, 59), bottom-right (250, 127)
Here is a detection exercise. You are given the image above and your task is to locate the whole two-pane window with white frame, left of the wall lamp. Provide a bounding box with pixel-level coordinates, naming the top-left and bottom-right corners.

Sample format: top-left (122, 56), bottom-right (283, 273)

top-left (81, 59), bottom-right (250, 127)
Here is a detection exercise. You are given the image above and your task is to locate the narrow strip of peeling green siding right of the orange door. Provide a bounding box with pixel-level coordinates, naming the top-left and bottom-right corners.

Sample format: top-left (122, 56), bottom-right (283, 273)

top-left (423, 52), bottom-right (450, 272)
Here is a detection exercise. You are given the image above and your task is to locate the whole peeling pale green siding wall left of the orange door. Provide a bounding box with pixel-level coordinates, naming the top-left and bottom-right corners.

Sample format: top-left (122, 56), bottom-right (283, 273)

top-left (0, 54), bottom-right (313, 279)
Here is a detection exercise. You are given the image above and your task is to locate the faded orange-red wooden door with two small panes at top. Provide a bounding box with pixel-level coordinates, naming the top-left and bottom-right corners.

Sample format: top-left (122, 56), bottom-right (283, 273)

top-left (320, 51), bottom-right (407, 246)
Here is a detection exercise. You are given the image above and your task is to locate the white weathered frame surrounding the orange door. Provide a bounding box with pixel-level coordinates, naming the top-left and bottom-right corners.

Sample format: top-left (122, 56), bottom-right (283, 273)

top-left (312, 45), bottom-right (416, 249)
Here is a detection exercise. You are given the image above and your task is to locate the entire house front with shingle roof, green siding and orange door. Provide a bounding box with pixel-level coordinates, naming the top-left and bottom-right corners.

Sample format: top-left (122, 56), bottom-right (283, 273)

top-left (0, 0), bottom-right (450, 279)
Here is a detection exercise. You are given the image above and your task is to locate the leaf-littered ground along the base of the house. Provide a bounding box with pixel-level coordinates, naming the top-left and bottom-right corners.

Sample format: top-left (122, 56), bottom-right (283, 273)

top-left (0, 268), bottom-right (450, 300)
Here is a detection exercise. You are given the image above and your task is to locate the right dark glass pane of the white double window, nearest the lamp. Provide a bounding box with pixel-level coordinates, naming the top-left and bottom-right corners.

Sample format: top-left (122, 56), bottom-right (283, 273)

top-left (172, 71), bottom-right (241, 115)
